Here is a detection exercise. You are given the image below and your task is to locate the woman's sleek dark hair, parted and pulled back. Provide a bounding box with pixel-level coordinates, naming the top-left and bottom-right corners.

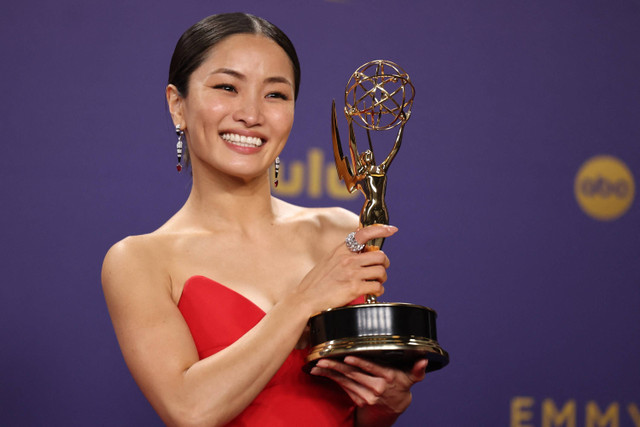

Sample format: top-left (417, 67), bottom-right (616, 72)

top-left (169, 12), bottom-right (300, 99)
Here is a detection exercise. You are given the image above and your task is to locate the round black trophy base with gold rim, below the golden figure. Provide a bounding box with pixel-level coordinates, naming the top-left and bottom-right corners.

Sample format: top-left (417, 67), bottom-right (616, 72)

top-left (305, 303), bottom-right (449, 372)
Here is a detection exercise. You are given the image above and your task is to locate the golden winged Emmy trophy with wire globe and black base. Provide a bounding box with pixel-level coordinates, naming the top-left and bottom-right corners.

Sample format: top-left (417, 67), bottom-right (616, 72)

top-left (306, 60), bottom-right (449, 371)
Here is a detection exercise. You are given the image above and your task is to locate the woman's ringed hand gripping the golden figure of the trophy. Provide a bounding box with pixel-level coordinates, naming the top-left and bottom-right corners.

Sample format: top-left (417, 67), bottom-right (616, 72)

top-left (296, 225), bottom-right (398, 315)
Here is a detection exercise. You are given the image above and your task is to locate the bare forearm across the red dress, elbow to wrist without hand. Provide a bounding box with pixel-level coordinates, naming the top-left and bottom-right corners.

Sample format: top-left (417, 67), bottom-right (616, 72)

top-left (150, 298), bottom-right (308, 425)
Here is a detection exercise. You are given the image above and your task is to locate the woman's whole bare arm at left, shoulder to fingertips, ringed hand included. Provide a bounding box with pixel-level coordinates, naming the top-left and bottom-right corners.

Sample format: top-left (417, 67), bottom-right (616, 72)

top-left (102, 227), bottom-right (395, 425)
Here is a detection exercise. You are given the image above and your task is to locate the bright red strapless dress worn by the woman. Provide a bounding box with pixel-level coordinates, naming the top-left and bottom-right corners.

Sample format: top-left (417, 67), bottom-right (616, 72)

top-left (178, 276), bottom-right (355, 427)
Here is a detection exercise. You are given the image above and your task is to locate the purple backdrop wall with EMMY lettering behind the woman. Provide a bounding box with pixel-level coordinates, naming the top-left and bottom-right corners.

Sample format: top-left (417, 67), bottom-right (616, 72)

top-left (0, 0), bottom-right (640, 427)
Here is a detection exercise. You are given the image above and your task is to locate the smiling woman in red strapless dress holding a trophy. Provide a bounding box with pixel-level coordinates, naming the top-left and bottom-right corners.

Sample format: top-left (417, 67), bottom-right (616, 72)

top-left (102, 14), bottom-right (426, 426)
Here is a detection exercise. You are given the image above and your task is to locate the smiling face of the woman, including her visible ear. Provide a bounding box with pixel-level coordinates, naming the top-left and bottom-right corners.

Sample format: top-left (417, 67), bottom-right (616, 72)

top-left (167, 34), bottom-right (295, 180)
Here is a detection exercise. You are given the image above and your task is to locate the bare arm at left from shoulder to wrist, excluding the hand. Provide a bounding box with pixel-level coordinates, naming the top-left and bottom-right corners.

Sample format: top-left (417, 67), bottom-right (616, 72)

top-left (102, 241), bottom-right (307, 425)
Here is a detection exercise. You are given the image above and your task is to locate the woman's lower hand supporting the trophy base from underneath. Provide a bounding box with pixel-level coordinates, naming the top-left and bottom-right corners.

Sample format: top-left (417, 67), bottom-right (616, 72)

top-left (311, 356), bottom-right (428, 422)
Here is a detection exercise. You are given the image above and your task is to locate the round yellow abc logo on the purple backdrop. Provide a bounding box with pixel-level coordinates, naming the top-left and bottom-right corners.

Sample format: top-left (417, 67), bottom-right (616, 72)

top-left (574, 155), bottom-right (635, 221)
